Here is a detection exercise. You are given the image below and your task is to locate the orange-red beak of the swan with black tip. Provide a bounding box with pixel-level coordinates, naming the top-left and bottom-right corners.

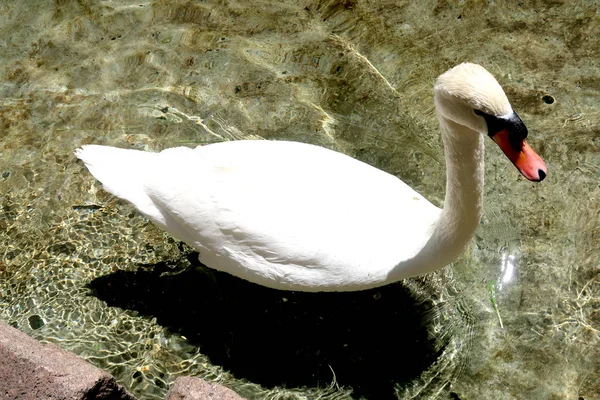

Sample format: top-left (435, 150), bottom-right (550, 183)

top-left (492, 129), bottom-right (548, 182)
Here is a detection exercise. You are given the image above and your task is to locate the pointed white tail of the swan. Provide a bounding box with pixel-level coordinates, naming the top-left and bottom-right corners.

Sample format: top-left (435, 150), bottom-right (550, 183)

top-left (75, 145), bottom-right (164, 224)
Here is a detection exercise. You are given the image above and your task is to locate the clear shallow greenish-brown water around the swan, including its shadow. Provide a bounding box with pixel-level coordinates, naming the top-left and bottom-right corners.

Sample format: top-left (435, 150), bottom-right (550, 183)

top-left (0, 0), bottom-right (600, 400)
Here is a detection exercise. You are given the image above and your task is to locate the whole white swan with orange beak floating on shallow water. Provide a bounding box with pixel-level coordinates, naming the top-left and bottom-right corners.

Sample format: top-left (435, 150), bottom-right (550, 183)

top-left (75, 63), bottom-right (546, 291)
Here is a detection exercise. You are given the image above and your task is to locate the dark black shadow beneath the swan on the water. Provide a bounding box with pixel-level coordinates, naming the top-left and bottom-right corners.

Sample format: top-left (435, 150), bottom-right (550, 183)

top-left (89, 253), bottom-right (443, 399)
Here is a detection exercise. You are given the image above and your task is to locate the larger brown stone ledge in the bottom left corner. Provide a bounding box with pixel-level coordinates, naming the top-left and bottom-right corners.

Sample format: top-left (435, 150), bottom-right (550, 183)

top-left (0, 321), bottom-right (135, 400)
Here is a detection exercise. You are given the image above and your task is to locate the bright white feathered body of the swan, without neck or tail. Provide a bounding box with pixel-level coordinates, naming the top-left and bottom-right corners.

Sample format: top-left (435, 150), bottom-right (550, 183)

top-left (143, 141), bottom-right (440, 289)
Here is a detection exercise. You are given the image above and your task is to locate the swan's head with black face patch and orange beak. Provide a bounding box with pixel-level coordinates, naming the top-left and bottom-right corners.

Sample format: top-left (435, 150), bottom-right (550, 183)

top-left (434, 63), bottom-right (547, 182)
